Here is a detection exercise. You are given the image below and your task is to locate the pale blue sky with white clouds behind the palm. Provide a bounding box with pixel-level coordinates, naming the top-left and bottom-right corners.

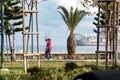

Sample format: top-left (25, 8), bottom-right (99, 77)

top-left (16, 0), bottom-right (97, 45)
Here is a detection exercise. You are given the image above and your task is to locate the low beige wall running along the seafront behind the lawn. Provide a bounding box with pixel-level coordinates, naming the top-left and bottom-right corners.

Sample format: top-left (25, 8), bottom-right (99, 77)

top-left (4, 52), bottom-right (105, 60)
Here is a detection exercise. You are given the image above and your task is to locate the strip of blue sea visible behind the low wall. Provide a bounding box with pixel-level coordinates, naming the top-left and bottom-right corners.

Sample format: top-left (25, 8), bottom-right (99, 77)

top-left (5, 45), bottom-right (120, 52)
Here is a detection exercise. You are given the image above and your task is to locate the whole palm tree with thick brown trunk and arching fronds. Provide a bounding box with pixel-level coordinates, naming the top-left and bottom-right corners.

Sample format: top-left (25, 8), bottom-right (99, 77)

top-left (58, 6), bottom-right (90, 59)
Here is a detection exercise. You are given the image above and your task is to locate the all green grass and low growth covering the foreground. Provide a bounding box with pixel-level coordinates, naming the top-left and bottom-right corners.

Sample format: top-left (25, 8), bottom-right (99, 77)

top-left (0, 61), bottom-right (120, 80)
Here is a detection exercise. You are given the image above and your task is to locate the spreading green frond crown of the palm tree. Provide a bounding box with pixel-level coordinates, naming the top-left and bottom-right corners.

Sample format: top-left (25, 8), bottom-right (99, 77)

top-left (58, 6), bottom-right (90, 33)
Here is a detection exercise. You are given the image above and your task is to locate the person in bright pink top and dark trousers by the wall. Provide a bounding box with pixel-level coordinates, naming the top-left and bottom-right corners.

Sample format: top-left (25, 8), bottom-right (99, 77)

top-left (45, 38), bottom-right (52, 60)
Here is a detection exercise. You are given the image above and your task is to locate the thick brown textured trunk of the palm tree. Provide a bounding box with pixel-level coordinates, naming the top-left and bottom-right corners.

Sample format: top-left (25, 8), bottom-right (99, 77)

top-left (67, 33), bottom-right (76, 59)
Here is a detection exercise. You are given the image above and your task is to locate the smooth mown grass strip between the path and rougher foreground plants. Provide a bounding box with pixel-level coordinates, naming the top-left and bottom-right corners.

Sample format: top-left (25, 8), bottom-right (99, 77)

top-left (4, 61), bottom-right (95, 73)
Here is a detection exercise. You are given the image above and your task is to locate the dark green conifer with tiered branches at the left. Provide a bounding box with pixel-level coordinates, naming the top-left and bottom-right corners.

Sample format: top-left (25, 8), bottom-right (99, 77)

top-left (4, 0), bottom-right (22, 61)
